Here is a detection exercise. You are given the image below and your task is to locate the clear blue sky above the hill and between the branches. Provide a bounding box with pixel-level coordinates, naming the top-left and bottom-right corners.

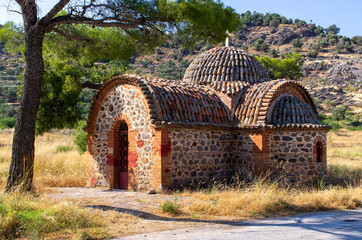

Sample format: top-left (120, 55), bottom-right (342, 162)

top-left (0, 0), bottom-right (362, 37)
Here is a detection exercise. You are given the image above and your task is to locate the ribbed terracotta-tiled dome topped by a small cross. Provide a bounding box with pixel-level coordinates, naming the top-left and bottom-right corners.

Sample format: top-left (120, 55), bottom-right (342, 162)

top-left (183, 47), bottom-right (268, 95)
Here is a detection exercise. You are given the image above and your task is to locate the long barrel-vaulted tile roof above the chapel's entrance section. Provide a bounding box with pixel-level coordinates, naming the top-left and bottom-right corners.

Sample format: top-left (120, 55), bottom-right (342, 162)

top-left (85, 75), bottom-right (231, 132)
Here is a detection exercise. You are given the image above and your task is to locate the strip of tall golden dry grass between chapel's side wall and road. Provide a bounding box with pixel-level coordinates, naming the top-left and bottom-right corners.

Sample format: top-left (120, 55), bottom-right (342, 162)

top-left (180, 180), bottom-right (362, 219)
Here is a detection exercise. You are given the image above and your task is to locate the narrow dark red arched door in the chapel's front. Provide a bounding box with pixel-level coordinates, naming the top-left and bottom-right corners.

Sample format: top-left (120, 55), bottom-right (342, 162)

top-left (119, 122), bottom-right (128, 189)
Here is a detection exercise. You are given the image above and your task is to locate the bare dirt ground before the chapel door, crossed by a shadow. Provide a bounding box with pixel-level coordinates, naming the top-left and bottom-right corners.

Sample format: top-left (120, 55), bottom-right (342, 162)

top-left (45, 187), bottom-right (235, 236)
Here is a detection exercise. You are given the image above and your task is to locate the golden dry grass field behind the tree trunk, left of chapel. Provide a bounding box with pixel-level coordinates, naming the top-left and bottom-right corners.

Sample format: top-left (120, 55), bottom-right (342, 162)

top-left (0, 133), bottom-right (86, 189)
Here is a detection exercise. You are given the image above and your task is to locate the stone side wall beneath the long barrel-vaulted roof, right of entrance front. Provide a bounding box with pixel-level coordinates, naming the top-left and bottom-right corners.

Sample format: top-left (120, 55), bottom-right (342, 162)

top-left (168, 129), bottom-right (236, 188)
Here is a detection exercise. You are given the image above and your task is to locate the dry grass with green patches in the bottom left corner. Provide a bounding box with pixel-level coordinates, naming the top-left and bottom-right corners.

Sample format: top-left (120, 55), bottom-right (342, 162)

top-left (0, 193), bottom-right (144, 239)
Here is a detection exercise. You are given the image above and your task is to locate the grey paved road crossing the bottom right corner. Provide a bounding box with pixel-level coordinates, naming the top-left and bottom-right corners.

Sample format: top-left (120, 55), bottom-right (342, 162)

top-left (118, 209), bottom-right (362, 240)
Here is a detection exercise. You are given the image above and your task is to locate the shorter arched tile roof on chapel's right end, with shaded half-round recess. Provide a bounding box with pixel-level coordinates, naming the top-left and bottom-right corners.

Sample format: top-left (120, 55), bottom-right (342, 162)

top-left (234, 79), bottom-right (319, 127)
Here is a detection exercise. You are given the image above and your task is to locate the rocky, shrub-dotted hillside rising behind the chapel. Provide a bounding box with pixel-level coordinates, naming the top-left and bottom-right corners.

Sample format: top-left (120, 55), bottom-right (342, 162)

top-left (0, 12), bottom-right (362, 129)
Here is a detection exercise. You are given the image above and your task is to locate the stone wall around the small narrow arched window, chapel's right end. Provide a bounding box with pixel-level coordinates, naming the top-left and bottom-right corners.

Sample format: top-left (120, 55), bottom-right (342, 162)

top-left (270, 131), bottom-right (327, 184)
